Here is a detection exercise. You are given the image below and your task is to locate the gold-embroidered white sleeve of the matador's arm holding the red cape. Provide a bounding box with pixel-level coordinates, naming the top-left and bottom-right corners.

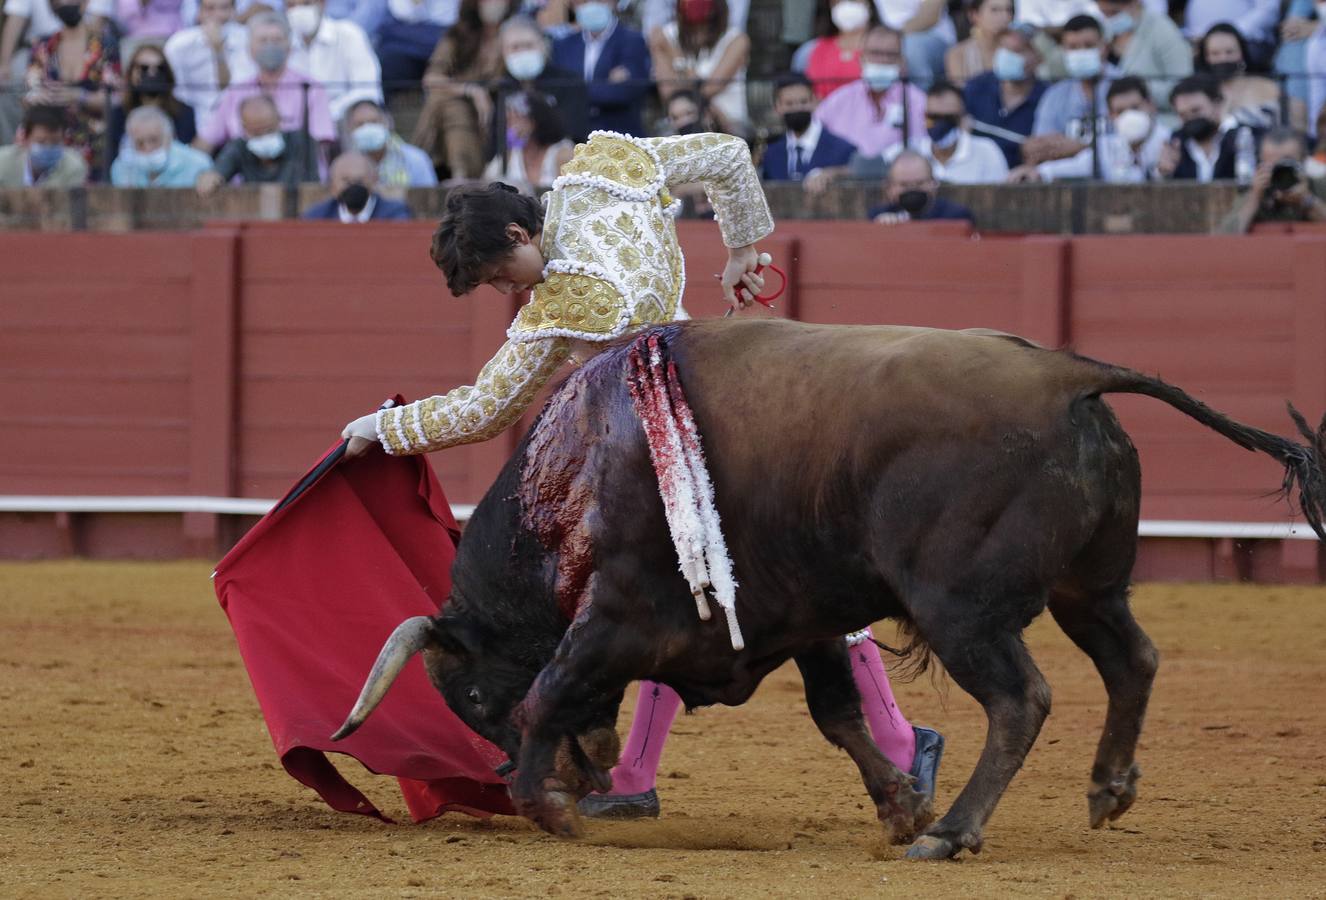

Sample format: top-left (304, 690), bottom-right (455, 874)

top-left (378, 338), bottom-right (570, 455)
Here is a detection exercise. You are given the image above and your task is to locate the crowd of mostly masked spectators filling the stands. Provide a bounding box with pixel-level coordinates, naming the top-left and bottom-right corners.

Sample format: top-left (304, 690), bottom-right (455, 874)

top-left (0, 0), bottom-right (1326, 225)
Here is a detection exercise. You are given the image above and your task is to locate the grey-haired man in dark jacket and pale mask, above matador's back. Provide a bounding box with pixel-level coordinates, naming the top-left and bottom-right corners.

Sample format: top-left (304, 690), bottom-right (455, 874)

top-left (488, 16), bottom-right (589, 147)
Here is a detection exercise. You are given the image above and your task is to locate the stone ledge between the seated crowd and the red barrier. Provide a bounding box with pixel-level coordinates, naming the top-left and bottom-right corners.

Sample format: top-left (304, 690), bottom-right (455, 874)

top-left (0, 182), bottom-right (1237, 235)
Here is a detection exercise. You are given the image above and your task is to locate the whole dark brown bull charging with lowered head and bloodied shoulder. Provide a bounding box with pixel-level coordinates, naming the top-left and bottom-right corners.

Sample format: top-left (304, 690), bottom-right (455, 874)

top-left (337, 321), bottom-right (1326, 859)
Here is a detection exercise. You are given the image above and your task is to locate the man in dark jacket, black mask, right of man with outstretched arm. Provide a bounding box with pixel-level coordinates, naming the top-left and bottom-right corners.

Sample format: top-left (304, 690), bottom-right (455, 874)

top-left (1158, 76), bottom-right (1262, 184)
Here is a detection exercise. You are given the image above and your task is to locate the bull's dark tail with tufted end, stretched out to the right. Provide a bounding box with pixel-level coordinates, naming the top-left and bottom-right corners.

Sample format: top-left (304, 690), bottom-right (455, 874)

top-left (1089, 361), bottom-right (1326, 541)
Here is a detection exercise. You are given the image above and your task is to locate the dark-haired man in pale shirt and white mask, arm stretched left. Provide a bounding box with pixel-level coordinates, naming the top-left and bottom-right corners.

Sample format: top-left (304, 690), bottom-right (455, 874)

top-left (1008, 76), bottom-right (1170, 184)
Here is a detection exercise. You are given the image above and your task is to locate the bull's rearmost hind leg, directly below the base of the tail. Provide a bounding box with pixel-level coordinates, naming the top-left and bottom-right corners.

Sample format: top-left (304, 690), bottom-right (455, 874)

top-left (1050, 586), bottom-right (1159, 828)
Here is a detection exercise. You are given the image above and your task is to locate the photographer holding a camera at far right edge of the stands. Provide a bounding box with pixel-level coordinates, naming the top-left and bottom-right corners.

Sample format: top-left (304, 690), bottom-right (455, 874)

top-left (1220, 129), bottom-right (1326, 235)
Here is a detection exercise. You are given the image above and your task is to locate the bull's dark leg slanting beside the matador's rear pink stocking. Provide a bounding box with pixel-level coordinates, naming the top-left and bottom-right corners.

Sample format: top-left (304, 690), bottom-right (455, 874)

top-left (796, 639), bottom-right (935, 843)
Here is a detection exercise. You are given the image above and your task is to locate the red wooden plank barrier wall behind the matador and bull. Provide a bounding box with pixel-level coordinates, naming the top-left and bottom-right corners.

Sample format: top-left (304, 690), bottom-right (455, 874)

top-left (0, 221), bottom-right (1326, 578)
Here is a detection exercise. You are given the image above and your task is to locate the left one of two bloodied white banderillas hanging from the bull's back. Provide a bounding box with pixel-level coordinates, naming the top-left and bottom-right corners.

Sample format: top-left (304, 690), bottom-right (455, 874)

top-left (629, 338), bottom-right (711, 620)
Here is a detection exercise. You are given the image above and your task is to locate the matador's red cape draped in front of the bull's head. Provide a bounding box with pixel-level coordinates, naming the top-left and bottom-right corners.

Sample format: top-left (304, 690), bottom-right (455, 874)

top-left (215, 434), bottom-right (513, 822)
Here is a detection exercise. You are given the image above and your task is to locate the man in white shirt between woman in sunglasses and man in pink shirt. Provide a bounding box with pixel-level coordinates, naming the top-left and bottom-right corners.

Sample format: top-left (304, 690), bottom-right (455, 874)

top-left (163, 0), bottom-right (253, 119)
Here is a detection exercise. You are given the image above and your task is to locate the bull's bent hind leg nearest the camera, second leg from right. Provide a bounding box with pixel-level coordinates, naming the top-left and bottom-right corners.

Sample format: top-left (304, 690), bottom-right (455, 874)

top-left (907, 615), bottom-right (1050, 859)
